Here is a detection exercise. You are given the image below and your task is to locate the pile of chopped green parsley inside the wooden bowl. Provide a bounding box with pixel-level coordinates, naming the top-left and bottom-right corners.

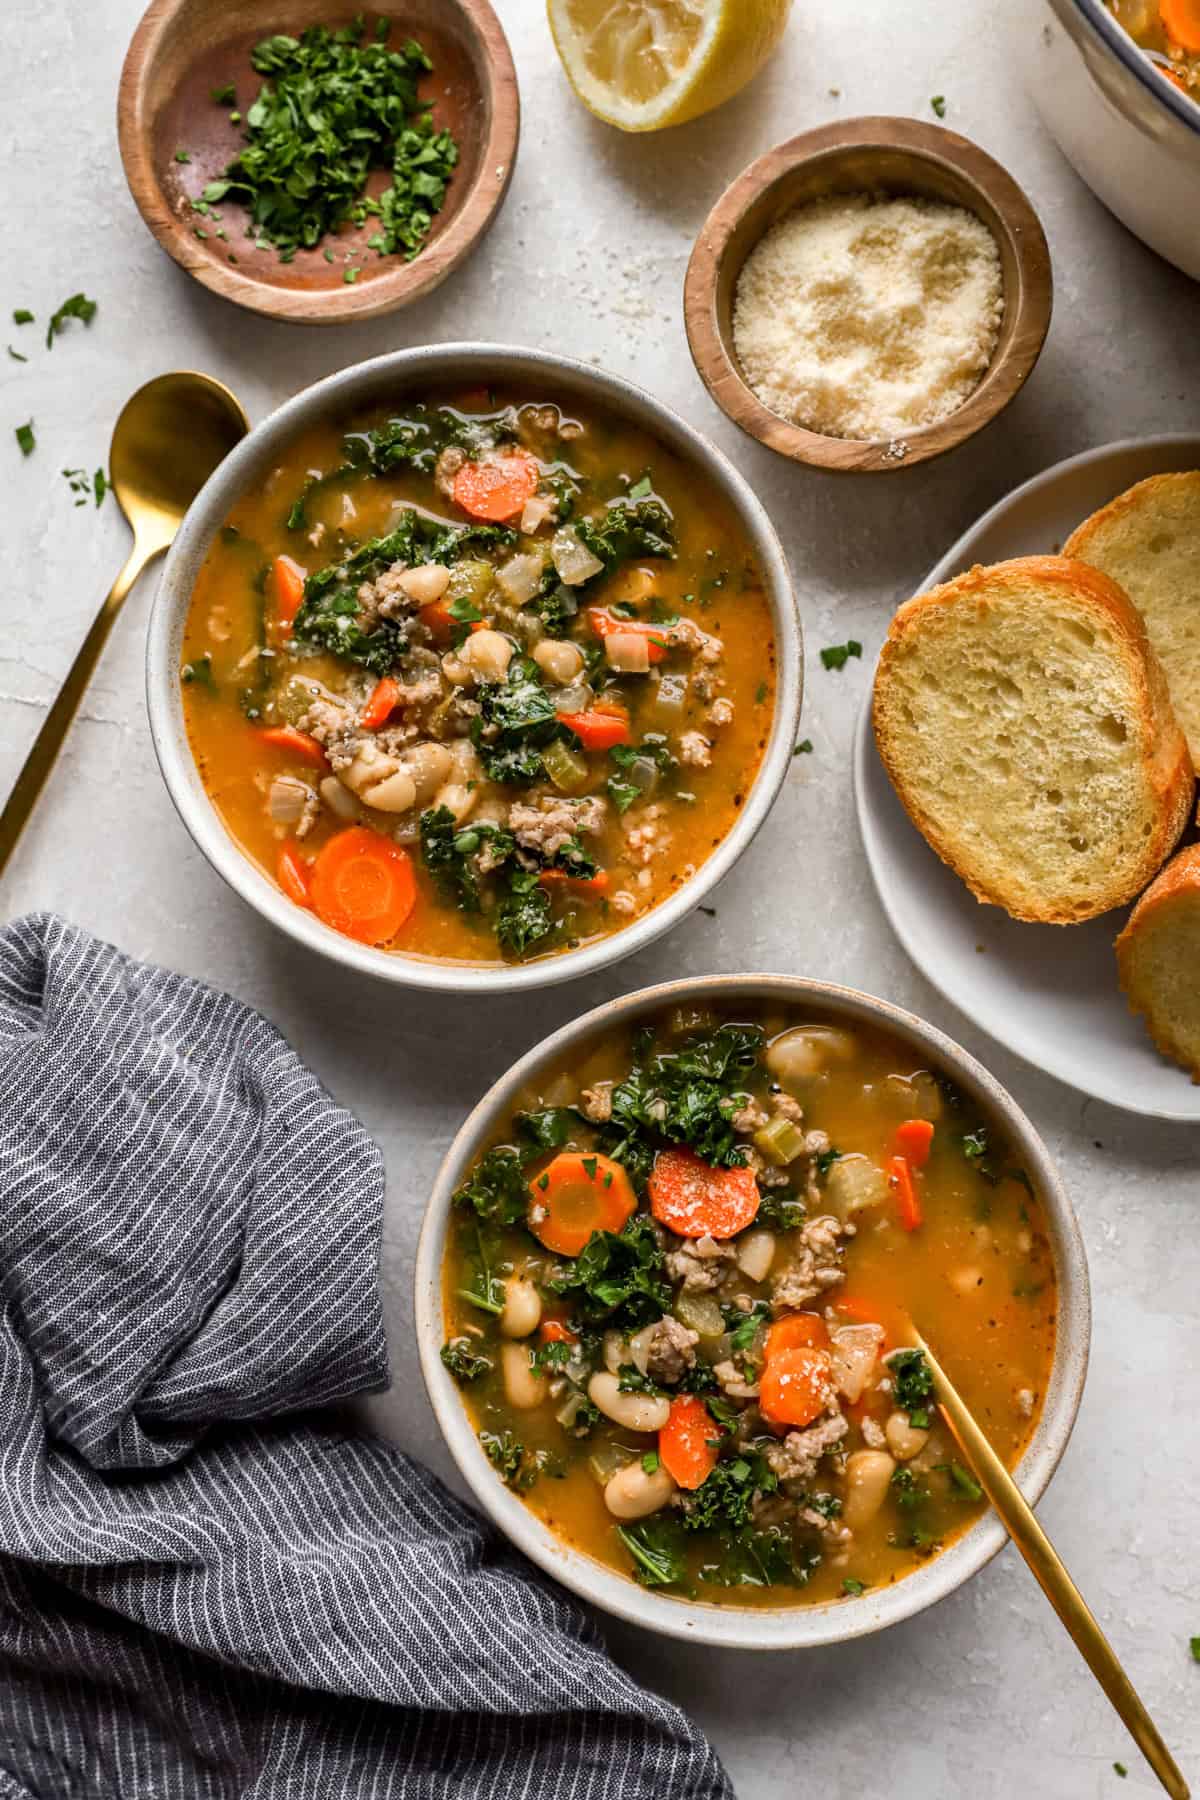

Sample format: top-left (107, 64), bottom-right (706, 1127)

top-left (200, 18), bottom-right (459, 262)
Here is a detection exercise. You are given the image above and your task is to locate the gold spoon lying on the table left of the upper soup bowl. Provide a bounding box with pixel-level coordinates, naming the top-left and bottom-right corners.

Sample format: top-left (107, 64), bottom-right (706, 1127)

top-left (0, 369), bottom-right (250, 875)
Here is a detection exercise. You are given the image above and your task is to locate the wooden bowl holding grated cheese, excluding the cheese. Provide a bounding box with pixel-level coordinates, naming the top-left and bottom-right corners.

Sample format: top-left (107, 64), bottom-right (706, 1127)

top-left (684, 119), bottom-right (1052, 470)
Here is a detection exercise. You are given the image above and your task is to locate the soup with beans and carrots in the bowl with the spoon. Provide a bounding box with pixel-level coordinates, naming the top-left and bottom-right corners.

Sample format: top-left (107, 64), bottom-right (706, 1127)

top-left (443, 1008), bottom-right (1056, 1606)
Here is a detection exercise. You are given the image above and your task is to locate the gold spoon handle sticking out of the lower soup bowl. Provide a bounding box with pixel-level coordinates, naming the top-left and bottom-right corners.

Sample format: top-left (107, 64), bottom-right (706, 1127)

top-left (912, 1327), bottom-right (1191, 1800)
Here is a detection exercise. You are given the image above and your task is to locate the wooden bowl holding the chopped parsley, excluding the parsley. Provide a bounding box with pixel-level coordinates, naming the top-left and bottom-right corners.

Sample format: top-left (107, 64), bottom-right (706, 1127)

top-left (117, 0), bottom-right (520, 326)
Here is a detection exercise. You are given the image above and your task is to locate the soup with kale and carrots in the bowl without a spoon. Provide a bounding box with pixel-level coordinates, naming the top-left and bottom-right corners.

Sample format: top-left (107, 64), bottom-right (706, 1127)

top-left (180, 391), bottom-right (775, 963)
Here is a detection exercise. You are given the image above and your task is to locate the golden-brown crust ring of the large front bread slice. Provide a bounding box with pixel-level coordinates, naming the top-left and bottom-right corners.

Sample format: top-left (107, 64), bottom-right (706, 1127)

top-left (871, 556), bottom-right (1195, 925)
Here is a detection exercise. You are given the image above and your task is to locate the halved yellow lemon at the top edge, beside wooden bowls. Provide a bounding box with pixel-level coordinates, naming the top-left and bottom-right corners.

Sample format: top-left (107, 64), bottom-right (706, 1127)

top-left (547, 0), bottom-right (792, 131)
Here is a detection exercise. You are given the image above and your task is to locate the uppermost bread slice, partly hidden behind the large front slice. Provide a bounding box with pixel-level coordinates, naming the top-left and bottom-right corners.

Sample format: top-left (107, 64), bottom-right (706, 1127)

top-left (1063, 470), bottom-right (1200, 770)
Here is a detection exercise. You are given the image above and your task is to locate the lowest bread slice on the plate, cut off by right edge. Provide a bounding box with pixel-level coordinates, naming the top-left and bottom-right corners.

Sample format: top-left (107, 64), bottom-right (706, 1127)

top-left (1117, 844), bottom-right (1200, 1082)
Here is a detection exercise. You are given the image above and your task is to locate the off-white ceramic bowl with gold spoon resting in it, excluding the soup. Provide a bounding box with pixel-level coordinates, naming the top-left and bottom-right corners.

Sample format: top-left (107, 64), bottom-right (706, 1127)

top-left (414, 976), bottom-right (1092, 1651)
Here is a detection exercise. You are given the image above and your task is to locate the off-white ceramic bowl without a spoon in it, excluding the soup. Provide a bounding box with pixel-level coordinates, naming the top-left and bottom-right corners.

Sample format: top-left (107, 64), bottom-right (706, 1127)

top-left (146, 344), bottom-right (804, 994)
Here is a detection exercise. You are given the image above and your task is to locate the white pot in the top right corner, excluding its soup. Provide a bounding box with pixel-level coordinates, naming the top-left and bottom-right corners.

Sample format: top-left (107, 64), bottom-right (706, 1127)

top-left (1009, 0), bottom-right (1200, 281)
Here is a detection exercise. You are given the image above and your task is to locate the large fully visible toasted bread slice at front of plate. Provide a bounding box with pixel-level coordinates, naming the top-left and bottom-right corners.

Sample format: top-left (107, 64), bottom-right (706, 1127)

top-left (873, 556), bottom-right (1193, 925)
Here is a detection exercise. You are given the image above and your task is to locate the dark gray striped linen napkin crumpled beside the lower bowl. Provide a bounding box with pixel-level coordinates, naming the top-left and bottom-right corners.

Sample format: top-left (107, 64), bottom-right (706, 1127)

top-left (0, 916), bottom-right (732, 1800)
